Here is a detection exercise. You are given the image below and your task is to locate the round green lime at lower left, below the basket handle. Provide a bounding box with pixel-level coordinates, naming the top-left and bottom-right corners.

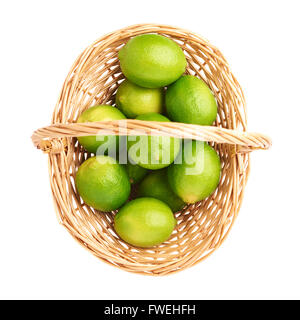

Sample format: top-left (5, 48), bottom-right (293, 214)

top-left (75, 156), bottom-right (131, 212)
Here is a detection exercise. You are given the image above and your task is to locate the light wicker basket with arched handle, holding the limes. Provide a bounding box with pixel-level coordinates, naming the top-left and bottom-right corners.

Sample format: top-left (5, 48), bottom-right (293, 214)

top-left (32, 24), bottom-right (271, 275)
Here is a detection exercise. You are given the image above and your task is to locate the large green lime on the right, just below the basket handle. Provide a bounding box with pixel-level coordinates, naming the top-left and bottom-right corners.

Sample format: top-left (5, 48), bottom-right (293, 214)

top-left (168, 141), bottom-right (221, 203)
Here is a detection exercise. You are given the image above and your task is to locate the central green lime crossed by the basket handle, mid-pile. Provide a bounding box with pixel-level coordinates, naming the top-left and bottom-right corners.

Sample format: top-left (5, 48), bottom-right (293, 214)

top-left (127, 113), bottom-right (180, 170)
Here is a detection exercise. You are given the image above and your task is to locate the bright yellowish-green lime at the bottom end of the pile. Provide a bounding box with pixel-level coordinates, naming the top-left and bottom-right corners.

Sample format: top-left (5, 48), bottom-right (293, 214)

top-left (114, 198), bottom-right (176, 248)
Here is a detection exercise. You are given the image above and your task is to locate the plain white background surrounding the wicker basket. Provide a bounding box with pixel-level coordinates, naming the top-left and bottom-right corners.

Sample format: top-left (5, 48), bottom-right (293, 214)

top-left (0, 0), bottom-right (300, 299)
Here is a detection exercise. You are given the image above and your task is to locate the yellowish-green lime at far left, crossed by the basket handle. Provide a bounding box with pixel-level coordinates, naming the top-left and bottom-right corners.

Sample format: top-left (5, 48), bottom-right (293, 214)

top-left (77, 105), bottom-right (126, 153)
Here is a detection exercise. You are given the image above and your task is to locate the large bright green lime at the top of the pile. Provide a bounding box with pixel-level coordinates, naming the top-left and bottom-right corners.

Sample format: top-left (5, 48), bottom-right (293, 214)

top-left (119, 34), bottom-right (187, 88)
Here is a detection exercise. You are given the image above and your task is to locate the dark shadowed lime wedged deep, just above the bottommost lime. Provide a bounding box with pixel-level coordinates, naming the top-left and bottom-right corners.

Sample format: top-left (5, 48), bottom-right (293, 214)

top-left (138, 169), bottom-right (185, 212)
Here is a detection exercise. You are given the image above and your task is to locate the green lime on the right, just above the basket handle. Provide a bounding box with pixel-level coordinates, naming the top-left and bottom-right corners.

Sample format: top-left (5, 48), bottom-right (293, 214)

top-left (166, 76), bottom-right (218, 125)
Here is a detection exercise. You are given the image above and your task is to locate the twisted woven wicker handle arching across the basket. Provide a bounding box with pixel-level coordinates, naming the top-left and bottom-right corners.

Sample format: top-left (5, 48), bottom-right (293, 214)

top-left (31, 119), bottom-right (271, 153)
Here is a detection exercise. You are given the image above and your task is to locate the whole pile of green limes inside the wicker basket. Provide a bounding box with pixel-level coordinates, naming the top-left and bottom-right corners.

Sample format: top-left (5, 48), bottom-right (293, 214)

top-left (75, 34), bottom-right (221, 248)
